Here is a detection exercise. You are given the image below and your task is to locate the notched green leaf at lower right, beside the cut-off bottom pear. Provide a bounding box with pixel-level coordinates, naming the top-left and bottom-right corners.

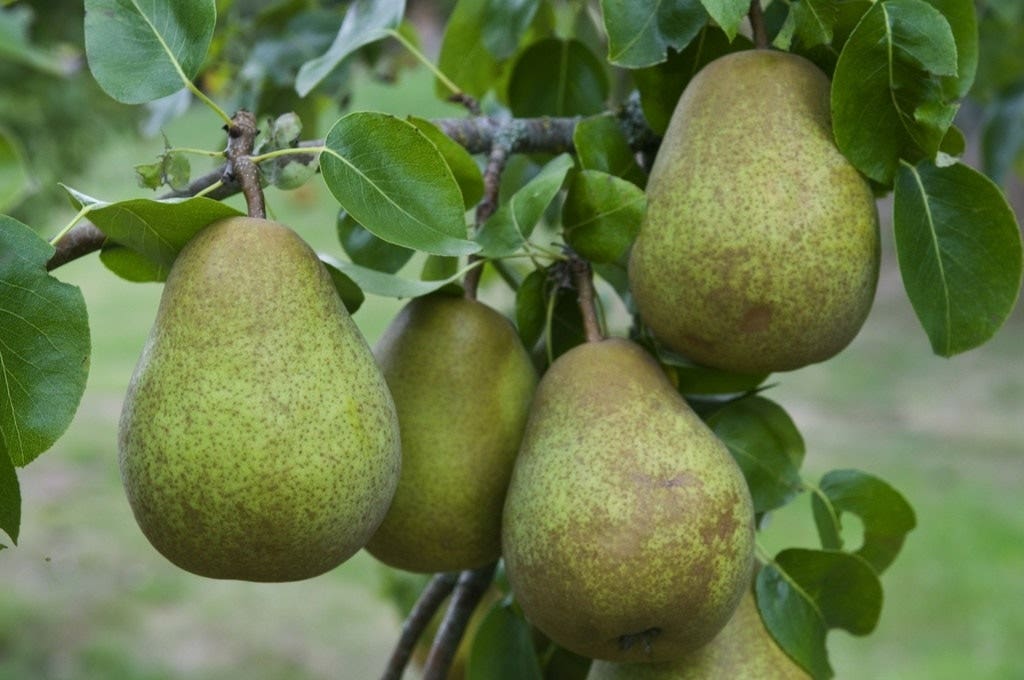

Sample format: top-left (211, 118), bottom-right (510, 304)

top-left (756, 548), bottom-right (882, 678)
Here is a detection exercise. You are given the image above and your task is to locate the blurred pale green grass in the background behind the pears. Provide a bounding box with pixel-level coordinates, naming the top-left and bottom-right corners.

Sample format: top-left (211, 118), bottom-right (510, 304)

top-left (0, 65), bottom-right (1024, 680)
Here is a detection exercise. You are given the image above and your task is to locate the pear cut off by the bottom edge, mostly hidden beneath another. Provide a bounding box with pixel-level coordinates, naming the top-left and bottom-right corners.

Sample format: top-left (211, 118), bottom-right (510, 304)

top-left (587, 590), bottom-right (811, 680)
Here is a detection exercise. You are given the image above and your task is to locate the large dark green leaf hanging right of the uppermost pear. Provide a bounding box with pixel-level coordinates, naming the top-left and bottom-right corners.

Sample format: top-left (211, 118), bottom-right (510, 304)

top-left (893, 163), bottom-right (1021, 356)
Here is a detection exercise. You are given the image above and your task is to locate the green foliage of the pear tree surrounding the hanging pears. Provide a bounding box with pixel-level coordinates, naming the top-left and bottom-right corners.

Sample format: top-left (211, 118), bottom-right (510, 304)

top-left (0, 0), bottom-right (1024, 678)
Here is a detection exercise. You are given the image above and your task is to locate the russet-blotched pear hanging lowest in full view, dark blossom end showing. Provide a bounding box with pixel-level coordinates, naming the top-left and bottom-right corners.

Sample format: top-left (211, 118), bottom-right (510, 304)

top-left (503, 339), bottom-right (754, 662)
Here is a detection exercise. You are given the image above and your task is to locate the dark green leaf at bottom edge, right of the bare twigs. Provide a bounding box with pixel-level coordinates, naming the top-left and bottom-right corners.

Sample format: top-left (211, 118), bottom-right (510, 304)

top-left (466, 600), bottom-right (543, 680)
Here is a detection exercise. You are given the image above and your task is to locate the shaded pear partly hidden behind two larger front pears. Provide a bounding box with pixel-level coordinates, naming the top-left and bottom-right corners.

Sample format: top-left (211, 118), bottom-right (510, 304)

top-left (367, 294), bottom-right (537, 572)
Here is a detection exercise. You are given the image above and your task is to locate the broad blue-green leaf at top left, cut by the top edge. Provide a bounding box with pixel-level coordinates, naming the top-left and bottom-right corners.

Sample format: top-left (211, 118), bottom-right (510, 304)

top-left (85, 0), bottom-right (217, 103)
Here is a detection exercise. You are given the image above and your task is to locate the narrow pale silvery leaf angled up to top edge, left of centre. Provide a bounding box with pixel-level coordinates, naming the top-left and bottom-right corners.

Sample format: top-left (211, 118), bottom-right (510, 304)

top-left (295, 0), bottom-right (406, 97)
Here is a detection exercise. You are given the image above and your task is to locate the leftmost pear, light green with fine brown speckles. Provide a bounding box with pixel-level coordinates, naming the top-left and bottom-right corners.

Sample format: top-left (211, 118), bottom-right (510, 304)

top-left (119, 217), bottom-right (401, 582)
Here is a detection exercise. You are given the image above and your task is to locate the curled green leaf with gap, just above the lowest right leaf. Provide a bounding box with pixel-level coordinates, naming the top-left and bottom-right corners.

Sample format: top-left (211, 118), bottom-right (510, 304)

top-left (812, 470), bottom-right (918, 573)
